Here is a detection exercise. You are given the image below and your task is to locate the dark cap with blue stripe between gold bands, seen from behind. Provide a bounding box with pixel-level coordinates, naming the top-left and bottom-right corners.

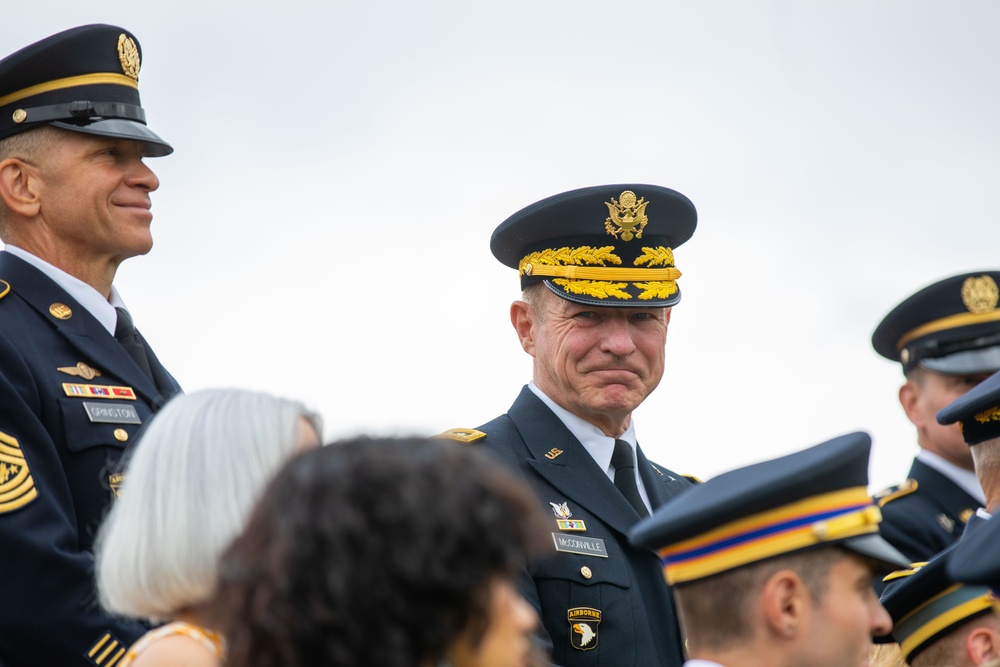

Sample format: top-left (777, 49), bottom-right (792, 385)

top-left (629, 433), bottom-right (908, 585)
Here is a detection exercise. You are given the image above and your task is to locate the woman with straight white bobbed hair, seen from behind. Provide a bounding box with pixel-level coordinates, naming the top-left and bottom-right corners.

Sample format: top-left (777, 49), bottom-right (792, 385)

top-left (96, 389), bottom-right (322, 667)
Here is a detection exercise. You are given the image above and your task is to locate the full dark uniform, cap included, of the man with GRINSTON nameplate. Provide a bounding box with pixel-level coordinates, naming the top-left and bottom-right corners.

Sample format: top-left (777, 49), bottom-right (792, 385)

top-left (0, 24), bottom-right (179, 667)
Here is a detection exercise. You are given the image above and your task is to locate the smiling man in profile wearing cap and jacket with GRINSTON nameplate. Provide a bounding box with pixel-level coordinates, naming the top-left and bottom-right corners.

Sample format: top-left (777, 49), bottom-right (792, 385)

top-left (0, 25), bottom-right (179, 667)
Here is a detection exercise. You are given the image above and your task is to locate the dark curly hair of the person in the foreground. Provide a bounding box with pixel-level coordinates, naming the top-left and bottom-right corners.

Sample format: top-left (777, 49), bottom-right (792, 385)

top-left (212, 439), bottom-right (546, 667)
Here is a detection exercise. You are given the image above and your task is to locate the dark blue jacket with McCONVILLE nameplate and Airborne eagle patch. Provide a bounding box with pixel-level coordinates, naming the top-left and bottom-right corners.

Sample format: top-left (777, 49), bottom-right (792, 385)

top-left (479, 387), bottom-right (692, 667)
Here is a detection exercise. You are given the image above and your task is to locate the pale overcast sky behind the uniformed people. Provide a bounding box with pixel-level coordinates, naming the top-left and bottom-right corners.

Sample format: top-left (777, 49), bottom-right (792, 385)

top-left (0, 0), bottom-right (1000, 487)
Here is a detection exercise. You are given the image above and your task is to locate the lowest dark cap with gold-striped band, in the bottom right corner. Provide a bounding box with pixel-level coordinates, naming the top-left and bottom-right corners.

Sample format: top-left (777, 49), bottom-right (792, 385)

top-left (876, 545), bottom-right (996, 662)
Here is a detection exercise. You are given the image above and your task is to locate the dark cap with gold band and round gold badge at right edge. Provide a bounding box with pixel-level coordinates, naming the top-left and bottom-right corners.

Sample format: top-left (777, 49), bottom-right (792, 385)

top-left (872, 271), bottom-right (1000, 375)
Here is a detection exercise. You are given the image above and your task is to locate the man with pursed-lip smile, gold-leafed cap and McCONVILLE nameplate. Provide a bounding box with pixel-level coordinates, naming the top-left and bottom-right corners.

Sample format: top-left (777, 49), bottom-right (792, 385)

top-left (451, 184), bottom-right (697, 667)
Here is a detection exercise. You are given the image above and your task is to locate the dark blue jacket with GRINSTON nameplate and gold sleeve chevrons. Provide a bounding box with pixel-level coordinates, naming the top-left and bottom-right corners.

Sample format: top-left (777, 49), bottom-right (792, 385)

top-left (0, 252), bottom-right (180, 667)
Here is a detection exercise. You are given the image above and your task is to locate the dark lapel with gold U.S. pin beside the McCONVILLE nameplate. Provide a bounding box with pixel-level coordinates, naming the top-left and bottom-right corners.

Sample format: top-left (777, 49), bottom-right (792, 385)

top-left (507, 387), bottom-right (652, 535)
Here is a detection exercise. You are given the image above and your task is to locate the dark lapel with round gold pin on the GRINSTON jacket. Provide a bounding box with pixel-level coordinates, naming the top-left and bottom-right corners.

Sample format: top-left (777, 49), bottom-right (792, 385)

top-left (0, 253), bottom-right (165, 409)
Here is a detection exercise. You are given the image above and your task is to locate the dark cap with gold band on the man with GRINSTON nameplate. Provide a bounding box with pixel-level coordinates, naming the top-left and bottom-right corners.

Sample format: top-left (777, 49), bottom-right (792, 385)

top-left (0, 25), bottom-right (174, 157)
